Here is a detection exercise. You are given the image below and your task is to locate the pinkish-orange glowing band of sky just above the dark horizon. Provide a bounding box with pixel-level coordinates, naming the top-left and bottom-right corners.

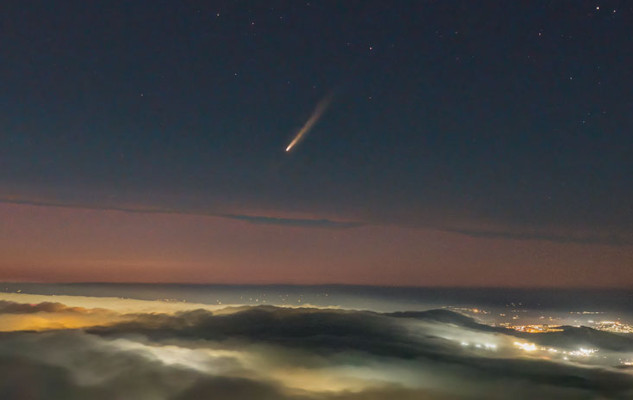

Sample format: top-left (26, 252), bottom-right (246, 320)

top-left (0, 203), bottom-right (633, 287)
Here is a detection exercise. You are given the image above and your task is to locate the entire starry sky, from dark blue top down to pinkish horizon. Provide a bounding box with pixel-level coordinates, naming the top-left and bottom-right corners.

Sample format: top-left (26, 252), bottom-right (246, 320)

top-left (0, 0), bottom-right (633, 287)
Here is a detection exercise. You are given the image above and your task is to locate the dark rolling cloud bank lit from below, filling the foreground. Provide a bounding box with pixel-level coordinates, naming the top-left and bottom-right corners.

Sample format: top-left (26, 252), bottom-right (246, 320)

top-left (0, 302), bottom-right (633, 400)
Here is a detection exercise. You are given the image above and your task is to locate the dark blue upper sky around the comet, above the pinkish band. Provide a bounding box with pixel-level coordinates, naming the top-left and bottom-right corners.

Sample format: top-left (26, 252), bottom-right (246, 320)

top-left (0, 1), bottom-right (633, 245)
